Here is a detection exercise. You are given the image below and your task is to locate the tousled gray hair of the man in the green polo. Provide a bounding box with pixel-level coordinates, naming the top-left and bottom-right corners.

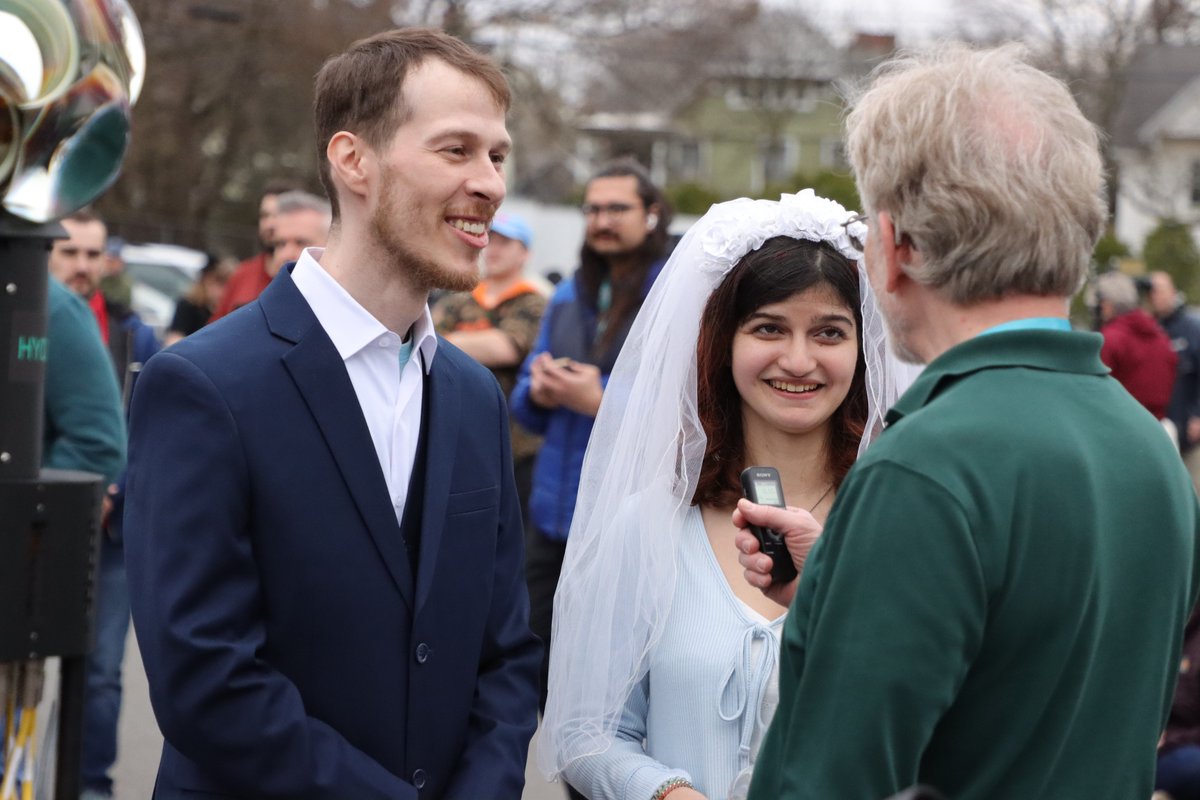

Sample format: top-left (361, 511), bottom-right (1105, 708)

top-left (846, 44), bottom-right (1108, 305)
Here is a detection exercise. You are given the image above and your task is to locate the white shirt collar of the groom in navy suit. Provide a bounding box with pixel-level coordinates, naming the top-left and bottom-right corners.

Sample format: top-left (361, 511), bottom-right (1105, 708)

top-left (292, 247), bottom-right (438, 373)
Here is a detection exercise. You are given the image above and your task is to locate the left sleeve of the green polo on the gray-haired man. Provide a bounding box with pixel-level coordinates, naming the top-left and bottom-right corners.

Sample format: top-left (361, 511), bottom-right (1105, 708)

top-left (751, 462), bottom-right (988, 800)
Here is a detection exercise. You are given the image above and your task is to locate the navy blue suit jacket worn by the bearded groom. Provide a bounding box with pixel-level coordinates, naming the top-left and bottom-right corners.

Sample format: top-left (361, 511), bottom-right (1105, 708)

top-left (125, 271), bottom-right (541, 800)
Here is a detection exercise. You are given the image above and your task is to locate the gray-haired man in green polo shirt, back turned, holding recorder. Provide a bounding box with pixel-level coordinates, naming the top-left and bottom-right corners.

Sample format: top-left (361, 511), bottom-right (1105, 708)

top-left (736, 47), bottom-right (1200, 800)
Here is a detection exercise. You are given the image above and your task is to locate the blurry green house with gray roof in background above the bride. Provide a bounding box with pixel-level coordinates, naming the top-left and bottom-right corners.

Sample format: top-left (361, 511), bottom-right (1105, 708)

top-left (576, 10), bottom-right (895, 197)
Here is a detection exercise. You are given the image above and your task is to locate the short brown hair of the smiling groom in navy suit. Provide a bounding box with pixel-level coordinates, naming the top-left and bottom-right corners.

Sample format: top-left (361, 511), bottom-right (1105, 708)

top-left (313, 28), bottom-right (511, 222)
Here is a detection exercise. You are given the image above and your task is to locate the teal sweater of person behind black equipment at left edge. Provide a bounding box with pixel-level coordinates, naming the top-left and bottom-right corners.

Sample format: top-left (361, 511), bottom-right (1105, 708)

top-left (42, 277), bottom-right (126, 485)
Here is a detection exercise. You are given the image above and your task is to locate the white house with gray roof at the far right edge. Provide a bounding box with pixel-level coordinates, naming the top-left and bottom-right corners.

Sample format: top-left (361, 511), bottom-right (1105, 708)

top-left (1112, 44), bottom-right (1200, 251)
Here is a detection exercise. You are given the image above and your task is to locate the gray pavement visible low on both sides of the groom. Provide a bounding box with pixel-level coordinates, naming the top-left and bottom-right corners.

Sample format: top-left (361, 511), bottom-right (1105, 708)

top-left (113, 631), bottom-right (566, 800)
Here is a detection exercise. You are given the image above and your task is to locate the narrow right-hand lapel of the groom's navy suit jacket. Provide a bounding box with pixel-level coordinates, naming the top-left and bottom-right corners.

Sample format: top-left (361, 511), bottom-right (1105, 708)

top-left (416, 354), bottom-right (460, 612)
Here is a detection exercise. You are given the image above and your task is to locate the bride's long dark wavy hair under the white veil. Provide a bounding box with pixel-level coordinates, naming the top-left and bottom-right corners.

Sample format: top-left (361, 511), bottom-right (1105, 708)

top-left (692, 236), bottom-right (866, 507)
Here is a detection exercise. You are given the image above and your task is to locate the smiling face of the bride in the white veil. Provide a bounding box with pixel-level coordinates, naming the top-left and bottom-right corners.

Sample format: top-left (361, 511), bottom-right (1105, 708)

top-left (732, 285), bottom-right (858, 434)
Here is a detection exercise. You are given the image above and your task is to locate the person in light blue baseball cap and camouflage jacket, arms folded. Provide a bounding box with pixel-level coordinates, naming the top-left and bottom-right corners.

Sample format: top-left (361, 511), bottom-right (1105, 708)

top-left (433, 213), bottom-right (546, 527)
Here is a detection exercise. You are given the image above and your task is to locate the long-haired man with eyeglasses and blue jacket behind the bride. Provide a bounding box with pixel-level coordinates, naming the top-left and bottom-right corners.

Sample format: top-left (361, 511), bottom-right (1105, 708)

top-left (511, 161), bottom-right (671, 796)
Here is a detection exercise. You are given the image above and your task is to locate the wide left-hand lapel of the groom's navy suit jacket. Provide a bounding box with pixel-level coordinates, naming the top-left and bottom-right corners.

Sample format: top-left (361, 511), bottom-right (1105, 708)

top-left (260, 276), bottom-right (413, 608)
